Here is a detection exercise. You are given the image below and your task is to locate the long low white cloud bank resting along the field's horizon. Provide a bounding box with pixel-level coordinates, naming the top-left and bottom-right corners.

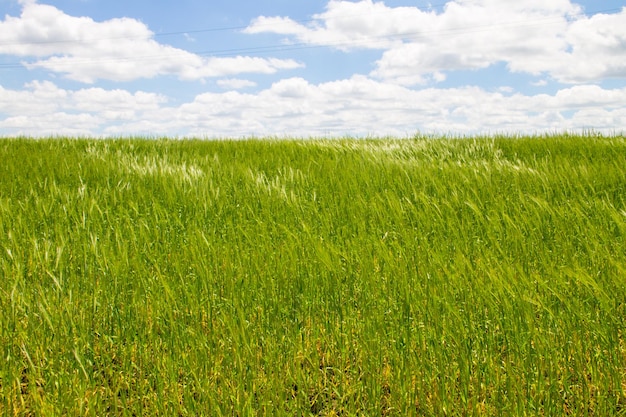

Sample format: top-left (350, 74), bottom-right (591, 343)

top-left (0, 76), bottom-right (626, 137)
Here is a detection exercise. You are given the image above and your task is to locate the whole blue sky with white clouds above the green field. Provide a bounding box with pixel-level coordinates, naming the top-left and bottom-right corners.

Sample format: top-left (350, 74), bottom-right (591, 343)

top-left (0, 0), bottom-right (626, 138)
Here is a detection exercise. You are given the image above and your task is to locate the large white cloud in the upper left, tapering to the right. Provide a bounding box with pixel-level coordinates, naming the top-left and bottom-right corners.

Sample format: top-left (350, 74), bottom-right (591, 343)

top-left (0, 1), bottom-right (301, 83)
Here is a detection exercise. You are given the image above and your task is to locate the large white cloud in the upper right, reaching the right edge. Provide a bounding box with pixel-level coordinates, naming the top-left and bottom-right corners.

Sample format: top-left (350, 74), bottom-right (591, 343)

top-left (246, 0), bottom-right (626, 85)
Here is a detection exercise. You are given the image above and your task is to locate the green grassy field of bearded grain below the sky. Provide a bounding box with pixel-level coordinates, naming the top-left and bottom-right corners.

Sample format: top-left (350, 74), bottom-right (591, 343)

top-left (0, 134), bottom-right (626, 416)
